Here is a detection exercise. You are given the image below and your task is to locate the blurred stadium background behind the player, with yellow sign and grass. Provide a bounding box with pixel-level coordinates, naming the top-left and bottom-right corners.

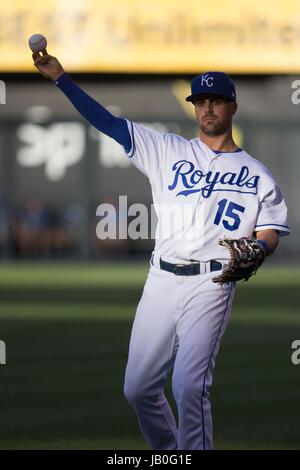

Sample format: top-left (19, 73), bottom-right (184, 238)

top-left (0, 0), bottom-right (300, 449)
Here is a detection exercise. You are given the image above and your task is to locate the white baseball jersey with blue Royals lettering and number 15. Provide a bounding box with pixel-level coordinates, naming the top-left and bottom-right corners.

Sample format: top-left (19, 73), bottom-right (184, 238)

top-left (123, 120), bottom-right (289, 262)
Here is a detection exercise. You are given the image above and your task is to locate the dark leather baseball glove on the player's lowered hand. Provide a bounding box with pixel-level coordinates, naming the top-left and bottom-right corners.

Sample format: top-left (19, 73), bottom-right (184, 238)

top-left (212, 237), bottom-right (266, 284)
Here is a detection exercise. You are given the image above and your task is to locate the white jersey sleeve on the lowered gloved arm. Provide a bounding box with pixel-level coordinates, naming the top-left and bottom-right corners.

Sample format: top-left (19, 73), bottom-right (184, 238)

top-left (255, 182), bottom-right (290, 236)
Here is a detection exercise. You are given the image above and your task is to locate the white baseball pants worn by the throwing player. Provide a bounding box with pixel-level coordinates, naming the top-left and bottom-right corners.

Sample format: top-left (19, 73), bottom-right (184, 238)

top-left (124, 266), bottom-right (235, 450)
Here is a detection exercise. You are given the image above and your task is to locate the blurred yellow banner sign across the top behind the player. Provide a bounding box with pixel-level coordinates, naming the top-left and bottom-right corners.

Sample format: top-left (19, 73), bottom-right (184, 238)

top-left (0, 0), bottom-right (300, 74)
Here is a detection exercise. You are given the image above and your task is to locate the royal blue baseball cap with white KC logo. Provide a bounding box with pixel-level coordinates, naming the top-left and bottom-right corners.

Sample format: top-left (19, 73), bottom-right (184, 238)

top-left (186, 72), bottom-right (236, 102)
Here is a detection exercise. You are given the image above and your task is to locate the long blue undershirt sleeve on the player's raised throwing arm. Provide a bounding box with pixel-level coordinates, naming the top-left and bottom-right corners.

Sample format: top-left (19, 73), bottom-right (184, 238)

top-left (55, 73), bottom-right (132, 153)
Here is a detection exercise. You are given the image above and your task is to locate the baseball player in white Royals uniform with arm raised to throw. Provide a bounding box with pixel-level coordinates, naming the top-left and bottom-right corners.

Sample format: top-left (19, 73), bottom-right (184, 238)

top-left (33, 50), bottom-right (289, 450)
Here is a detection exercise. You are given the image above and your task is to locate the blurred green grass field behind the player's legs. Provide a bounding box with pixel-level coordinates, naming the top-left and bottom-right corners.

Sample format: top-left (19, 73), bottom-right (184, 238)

top-left (0, 263), bottom-right (300, 450)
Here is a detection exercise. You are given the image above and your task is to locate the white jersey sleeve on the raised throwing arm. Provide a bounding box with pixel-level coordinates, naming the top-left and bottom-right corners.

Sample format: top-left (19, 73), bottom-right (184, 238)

top-left (126, 120), bottom-right (165, 178)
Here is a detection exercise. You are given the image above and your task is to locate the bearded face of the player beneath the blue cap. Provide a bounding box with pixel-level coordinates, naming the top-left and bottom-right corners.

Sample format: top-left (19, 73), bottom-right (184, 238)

top-left (195, 95), bottom-right (237, 136)
